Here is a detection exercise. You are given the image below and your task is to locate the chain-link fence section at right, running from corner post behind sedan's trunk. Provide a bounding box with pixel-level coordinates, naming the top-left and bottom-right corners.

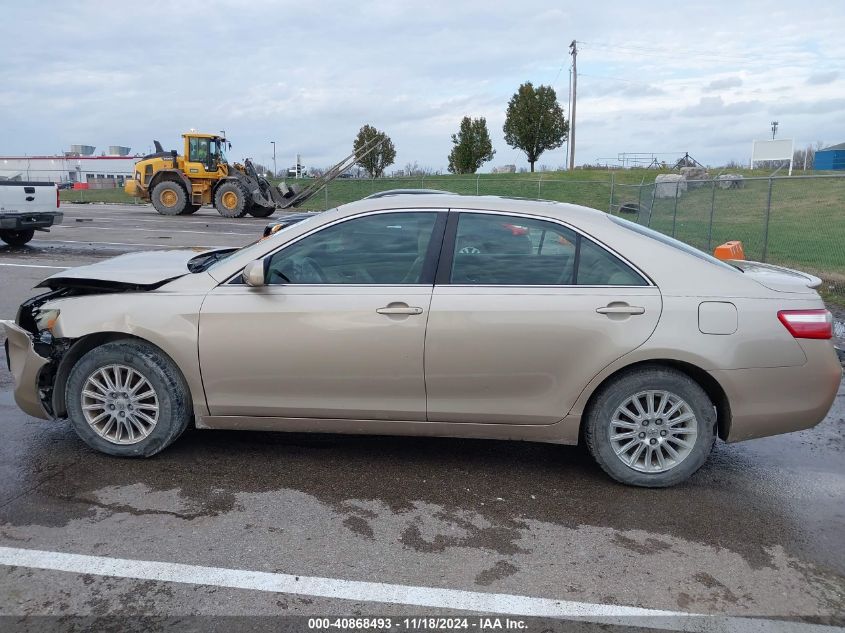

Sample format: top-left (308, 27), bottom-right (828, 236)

top-left (609, 176), bottom-right (845, 303)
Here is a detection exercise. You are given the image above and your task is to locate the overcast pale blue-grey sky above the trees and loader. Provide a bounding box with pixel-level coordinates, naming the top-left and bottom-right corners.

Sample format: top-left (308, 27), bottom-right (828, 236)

top-left (0, 0), bottom-right (845, 171)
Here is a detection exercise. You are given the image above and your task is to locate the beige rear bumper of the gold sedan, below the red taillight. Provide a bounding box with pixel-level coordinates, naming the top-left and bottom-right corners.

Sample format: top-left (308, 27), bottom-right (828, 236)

top-left (710, 340), bottom-right (842, 442)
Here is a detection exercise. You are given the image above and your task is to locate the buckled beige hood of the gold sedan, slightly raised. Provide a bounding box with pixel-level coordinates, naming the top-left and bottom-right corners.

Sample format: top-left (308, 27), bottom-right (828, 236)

top-left (37, 248), bottom-right (209, 290)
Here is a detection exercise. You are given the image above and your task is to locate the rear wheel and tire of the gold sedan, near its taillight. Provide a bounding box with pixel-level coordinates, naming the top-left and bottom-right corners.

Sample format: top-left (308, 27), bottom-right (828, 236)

top-left (584, 366), bottom-right (716, 488)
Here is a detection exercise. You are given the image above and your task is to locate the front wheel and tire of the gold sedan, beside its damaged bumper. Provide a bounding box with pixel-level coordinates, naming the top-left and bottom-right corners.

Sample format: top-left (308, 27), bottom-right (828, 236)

top-left (65, 340), bottom-right (193, 457)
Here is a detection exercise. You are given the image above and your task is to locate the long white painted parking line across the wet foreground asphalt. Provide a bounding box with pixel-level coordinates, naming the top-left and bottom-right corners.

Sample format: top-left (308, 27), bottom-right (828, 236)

top-left (0, 547), bottom-right (832, 632)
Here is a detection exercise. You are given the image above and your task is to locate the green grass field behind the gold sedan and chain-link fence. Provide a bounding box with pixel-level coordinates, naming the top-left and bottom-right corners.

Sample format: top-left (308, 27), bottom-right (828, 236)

top-left (61, 169), bottom-right (845, 303)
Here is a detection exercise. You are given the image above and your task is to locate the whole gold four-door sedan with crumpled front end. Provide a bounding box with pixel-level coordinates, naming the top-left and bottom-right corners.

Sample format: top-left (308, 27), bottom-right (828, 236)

top-left (5, 194), bottom-right (841, 487)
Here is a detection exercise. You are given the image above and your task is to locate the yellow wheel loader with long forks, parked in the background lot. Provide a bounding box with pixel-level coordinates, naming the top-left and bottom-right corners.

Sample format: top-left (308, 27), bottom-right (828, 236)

top-left (124, 132), bottom-right (380, 218)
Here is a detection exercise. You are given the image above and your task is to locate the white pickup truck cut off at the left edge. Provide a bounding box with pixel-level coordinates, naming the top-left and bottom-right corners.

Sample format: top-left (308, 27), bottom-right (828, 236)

top-left (0, 180), bottom-right (63, 246)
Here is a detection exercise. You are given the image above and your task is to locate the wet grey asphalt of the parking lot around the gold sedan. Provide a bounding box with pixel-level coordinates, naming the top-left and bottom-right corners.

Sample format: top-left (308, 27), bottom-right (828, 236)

top-left (0, 205), bottom-right (845, 626)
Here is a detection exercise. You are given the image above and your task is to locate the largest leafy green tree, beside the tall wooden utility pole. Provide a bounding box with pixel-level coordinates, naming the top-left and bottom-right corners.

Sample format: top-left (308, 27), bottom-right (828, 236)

top-left (503, 81), bottom-right (569, 172)
